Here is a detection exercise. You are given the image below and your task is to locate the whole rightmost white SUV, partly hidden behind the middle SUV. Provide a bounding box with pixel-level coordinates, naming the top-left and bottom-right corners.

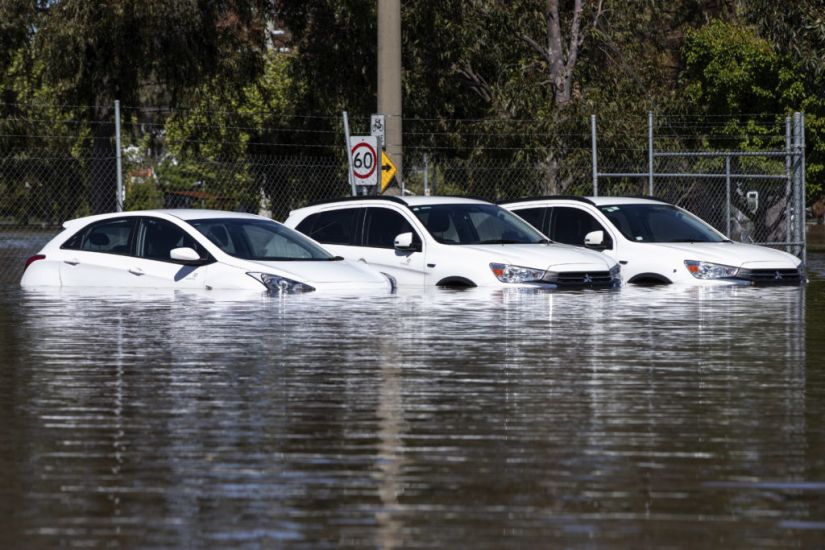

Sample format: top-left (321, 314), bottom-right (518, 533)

top-left (502, 197), bottom-right (805, 285)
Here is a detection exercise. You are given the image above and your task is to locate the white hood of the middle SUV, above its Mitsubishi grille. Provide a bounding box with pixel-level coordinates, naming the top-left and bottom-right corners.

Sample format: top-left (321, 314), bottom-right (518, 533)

top-left (461, 243), bottom-right (616, 271)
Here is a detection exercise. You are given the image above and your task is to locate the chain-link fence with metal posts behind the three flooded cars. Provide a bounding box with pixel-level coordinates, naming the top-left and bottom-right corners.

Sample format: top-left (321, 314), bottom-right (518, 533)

top-left (0, 110), bottom-right (804, 283)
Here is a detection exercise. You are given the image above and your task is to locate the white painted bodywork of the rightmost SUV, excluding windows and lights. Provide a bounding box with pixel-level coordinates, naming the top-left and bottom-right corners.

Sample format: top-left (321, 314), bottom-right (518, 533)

top-left (501, 197), bottom-right (801, 286)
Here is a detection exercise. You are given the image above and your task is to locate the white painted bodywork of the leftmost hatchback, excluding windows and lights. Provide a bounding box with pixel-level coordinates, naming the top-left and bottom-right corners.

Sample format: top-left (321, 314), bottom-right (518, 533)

top-left (20, 210), bottom-right (391, 292)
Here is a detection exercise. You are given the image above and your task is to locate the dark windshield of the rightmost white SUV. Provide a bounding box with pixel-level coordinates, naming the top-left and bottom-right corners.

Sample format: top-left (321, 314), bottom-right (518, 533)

top-left (599, 204), bottom-right (727, 243)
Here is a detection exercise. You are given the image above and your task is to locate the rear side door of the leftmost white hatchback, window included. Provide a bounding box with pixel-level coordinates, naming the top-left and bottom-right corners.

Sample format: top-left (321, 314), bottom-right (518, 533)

top-left (60, 217), bottom-right (138, 287)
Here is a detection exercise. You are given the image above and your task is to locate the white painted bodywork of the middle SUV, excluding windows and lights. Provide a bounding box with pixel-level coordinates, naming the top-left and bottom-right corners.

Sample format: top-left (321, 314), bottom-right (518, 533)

top-left (284, 197), bottom-right (616, 287)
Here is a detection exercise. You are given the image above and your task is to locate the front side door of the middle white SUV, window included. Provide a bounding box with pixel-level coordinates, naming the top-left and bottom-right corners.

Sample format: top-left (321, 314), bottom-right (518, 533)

top-left (357, 206), bottom-right (426, 285)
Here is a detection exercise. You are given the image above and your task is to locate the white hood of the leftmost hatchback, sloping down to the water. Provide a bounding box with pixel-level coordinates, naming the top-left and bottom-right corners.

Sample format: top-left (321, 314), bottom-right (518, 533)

top-left (247, 260), bottom-right (387, 285)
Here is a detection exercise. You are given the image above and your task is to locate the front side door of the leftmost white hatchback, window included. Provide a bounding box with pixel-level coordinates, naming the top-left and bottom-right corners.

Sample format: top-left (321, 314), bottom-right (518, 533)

top-left (128, 217), bottom-right (210, 288)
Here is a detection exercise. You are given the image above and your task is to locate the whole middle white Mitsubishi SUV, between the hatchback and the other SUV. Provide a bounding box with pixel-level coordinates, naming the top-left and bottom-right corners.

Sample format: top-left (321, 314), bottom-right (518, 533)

top-left (284, 196), bottom-right (621, 288)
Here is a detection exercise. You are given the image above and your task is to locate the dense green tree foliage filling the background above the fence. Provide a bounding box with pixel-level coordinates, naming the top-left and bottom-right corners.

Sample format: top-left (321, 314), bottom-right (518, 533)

top-left (0, 0), bottom-right (825, 218)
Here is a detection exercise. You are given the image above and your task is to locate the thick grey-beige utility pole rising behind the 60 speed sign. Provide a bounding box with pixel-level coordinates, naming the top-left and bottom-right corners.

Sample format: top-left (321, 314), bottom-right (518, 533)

top-left (376, 0), bottom-right (403, 192)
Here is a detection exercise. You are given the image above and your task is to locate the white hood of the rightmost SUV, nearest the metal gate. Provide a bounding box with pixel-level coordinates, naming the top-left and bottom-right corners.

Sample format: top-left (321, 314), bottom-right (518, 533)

top-left (651, 242), bottom-right (800, 269)
